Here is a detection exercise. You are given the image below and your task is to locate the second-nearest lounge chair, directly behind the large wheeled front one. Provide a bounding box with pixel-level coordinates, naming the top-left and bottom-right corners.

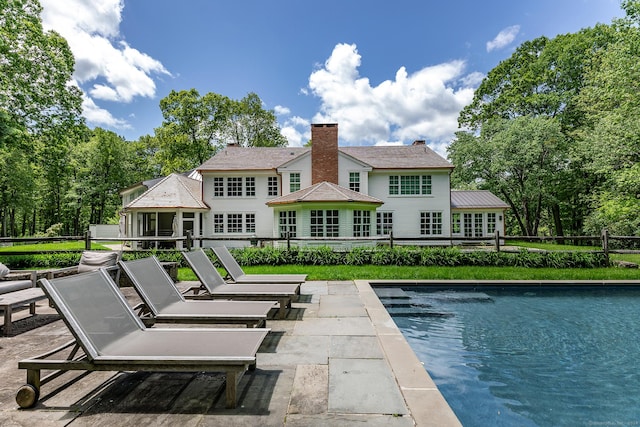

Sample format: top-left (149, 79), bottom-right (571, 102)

top-left (119, 256), bottom-right (276, 327)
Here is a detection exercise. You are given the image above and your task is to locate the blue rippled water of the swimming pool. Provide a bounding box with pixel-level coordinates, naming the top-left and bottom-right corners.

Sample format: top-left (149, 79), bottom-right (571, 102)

top-left (375, 287), bottom-right (640, 427)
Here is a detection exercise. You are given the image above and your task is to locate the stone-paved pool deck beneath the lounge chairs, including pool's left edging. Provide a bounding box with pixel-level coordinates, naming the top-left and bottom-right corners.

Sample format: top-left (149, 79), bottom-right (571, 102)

top-left (0, 281), bottom-right (460, 427)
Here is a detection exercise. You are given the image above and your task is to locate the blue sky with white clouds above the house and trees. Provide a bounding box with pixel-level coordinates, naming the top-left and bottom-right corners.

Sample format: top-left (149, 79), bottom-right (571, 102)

top-left (41, 0), bottom-right (624, 154)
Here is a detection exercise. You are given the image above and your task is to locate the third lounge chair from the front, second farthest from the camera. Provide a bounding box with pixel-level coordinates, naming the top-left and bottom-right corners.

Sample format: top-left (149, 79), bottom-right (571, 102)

top-left (182, 249), bottom-right (300, 319)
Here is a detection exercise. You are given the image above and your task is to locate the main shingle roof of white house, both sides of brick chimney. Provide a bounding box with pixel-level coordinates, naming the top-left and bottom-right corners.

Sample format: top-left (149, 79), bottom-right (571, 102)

top-left (198, 145), bottom-right (453, 172)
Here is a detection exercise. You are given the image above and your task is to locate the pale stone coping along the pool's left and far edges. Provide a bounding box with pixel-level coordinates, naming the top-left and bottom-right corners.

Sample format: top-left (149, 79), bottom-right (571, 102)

top-left (354, 279), bottom-right (640, 426)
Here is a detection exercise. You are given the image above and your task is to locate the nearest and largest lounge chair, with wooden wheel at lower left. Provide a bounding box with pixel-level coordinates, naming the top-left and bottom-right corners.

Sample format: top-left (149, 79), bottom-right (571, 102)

top-left (16, 270), bottom-right (269, 408)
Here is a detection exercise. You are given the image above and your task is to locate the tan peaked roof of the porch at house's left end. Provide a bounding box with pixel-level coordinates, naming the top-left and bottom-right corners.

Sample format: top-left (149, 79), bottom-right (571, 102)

top-left (124, 173), bottom-right (209, 210)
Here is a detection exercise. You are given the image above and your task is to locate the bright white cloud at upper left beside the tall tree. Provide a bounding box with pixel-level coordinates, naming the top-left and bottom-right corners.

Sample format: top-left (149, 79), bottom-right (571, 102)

top-left (41, 0), bottom-right (171, 127)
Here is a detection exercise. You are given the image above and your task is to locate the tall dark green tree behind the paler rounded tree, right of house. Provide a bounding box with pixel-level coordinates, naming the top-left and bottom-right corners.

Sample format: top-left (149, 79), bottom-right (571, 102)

top-left (454, 25), bottom-right (615, 235)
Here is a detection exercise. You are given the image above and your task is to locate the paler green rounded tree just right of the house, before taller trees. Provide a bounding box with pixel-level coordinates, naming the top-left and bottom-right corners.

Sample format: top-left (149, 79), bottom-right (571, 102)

top-left (448, 115), bottom-right (566, 236)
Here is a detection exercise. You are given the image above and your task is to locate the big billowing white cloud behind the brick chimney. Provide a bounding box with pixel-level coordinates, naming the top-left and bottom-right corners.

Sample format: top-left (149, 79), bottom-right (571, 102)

top-left (296, 44), bottom-right (478, 155)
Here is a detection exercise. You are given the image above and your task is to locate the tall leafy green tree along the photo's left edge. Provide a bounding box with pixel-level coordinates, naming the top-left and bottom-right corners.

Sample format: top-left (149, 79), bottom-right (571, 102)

top-left (0, 0), bottom-right (83, 235)
